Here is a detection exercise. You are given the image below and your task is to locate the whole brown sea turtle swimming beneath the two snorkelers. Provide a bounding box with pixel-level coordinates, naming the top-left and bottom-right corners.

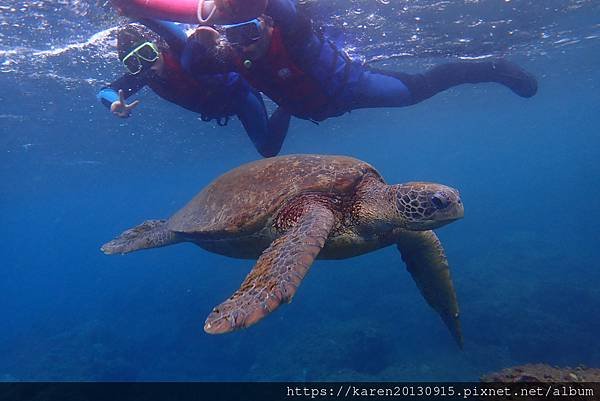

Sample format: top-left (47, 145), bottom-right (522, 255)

top-left (101, 155), bottom-right (464, 346)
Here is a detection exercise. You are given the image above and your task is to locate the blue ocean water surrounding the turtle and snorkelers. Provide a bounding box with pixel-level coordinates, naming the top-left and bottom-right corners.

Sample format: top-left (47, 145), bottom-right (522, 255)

top-left (0, 1), bottom-right (600, 381)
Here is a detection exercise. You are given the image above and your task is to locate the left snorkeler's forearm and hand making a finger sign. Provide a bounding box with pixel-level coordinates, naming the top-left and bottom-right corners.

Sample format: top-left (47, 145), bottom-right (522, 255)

top-left (96, 74), bottom-right (146, 118)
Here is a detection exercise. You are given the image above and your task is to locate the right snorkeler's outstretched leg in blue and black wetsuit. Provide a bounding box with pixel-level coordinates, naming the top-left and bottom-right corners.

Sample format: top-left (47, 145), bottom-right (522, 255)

top-left (353, 60), bottom-right (537, 108)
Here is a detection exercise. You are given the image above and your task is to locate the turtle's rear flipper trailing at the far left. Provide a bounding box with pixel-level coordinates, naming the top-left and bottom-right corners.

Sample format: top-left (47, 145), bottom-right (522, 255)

top-left (100, 220), bottom-right (181, 255)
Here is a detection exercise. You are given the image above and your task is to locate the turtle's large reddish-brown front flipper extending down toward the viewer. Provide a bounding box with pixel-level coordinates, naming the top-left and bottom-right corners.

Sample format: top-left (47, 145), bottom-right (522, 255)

top-left (204, 203), bottom-right (334, 334)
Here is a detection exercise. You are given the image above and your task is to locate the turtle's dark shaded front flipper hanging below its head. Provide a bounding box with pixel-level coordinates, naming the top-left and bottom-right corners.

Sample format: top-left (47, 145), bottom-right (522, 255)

top-left (397, 231), bottom-right (463, 349)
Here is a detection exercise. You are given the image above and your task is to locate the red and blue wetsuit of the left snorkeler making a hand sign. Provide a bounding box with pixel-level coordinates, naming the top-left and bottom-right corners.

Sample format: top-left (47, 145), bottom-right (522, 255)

top-left (98, 19), bottom-right (289, 157)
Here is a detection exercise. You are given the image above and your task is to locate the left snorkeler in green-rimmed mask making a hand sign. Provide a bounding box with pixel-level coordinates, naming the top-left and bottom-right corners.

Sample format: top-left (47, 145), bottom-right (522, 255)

top-left (98, 20), bottom-right (290, 157)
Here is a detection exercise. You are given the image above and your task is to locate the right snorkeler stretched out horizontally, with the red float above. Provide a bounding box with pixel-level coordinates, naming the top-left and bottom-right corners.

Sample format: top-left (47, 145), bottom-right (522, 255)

top-left (113, 0), bottom-right (537, 121)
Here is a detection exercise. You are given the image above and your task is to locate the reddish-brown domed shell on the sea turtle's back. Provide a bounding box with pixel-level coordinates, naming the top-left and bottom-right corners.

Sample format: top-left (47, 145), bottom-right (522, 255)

top-left (168, 155), bottom-right (381, 237)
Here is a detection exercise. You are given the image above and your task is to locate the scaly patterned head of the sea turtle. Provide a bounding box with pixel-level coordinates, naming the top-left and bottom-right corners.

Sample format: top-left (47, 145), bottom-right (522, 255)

top-left (394, 182), bottom-right (465, 231)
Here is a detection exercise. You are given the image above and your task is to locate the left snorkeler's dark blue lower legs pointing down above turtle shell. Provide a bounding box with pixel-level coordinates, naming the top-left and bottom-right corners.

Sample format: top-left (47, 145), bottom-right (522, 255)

top-left (237, 89), bottom-right (290, 157)
